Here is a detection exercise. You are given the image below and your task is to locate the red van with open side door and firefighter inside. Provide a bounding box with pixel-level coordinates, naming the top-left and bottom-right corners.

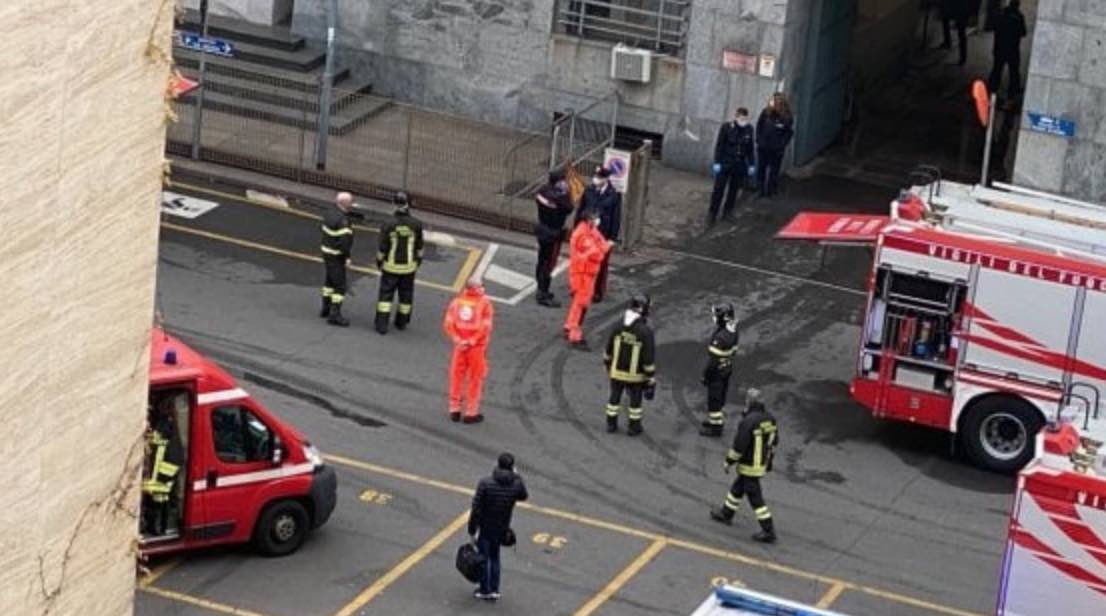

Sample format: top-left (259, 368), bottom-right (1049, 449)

top-left (139, 327), bottom-right (337, 555)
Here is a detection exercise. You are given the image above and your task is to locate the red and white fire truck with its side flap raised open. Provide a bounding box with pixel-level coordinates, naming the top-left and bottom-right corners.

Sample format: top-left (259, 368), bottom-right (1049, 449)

top-left (778, 178), bottom-right (1106, 472)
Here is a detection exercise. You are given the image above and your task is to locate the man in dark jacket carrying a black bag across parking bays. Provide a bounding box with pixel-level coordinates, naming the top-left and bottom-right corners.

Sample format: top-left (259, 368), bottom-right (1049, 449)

top-left (469, 453), bottom-right (530, 601)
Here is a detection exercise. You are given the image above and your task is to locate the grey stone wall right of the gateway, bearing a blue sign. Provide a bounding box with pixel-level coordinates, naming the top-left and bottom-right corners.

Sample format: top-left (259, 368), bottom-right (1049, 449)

top-left (1014, 0), bottom-right (1106, 202)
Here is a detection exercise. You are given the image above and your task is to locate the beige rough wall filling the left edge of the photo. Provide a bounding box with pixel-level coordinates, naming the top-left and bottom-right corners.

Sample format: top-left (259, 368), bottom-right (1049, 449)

top-left (0, 0), bottom-right (173, 616)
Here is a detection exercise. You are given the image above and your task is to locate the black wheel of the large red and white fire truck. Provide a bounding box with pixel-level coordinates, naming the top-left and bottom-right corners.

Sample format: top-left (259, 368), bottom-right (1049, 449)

top-left (960, 396), bottom-right (1044, 472)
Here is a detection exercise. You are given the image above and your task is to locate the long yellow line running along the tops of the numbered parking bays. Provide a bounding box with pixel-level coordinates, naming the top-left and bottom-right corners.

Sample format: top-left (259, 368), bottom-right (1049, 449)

top-left (325, 455), bottom-right (982, 616)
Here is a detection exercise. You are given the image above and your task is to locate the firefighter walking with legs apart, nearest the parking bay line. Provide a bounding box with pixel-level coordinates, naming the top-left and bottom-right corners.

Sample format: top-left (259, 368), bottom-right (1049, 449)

top-left (710, 387), bottom-right (780, 543)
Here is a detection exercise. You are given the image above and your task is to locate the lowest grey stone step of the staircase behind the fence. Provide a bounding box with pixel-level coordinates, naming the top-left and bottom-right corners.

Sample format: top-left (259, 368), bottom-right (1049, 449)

top-left (177, 92), bottom-right (392, 136)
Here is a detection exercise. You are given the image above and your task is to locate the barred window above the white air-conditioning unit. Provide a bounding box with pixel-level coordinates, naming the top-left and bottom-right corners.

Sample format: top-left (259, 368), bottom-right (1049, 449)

top-left (554, 0), bottom-right (691, 55)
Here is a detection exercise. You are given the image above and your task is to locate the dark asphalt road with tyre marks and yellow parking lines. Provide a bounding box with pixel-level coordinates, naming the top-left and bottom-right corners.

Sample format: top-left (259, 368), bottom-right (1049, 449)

top-left (136, 175), bottom-right (1013, 615)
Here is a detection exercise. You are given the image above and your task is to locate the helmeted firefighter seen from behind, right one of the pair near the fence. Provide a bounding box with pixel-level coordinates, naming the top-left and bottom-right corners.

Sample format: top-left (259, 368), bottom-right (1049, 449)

top-left (376, 192), bottom-right (422, 335)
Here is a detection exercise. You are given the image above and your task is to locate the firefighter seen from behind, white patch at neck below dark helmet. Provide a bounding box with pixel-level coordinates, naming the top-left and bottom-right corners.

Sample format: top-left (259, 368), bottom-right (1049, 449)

top-left (603, 295), bottom-right (657, 437)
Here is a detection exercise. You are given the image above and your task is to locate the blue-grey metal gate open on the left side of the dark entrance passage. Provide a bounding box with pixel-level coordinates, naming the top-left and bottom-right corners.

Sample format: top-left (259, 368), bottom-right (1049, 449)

top-left (795, 0), bottom-right (856, 165)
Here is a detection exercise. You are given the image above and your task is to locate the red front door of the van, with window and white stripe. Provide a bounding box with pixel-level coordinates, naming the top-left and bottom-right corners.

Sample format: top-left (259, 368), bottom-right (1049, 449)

top-left (197, 399), bottom-right (280, 541)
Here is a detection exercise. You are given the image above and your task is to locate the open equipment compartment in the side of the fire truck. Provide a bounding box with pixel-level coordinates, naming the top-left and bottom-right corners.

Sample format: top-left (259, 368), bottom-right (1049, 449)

top-left (859, 265), bottom-right (968, 395)
